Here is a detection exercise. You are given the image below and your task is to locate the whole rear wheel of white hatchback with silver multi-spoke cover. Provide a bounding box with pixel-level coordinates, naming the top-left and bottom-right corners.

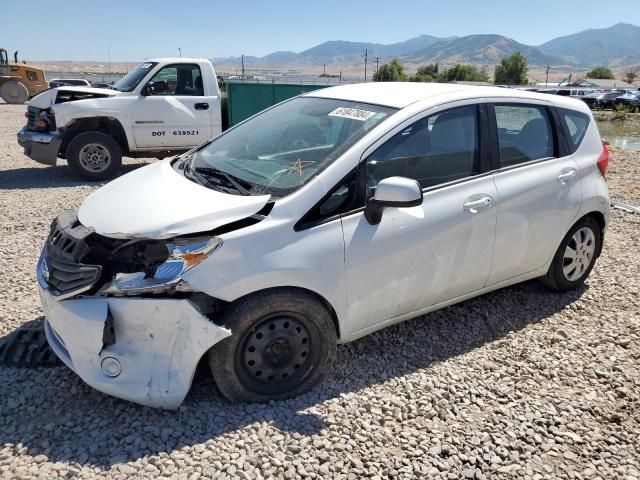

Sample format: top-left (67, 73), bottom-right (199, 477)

top-left (540, 217), bottom-right (602, 292)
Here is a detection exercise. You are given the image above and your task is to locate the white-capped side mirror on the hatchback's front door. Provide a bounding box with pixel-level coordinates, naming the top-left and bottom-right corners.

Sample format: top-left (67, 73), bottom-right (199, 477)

top-left (364, 177), bottom-right (422, 225)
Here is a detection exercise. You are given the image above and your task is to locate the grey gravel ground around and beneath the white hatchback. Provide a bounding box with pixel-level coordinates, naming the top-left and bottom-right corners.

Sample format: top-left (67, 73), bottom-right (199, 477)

top-left (0, 104), bottom-right (640, 480)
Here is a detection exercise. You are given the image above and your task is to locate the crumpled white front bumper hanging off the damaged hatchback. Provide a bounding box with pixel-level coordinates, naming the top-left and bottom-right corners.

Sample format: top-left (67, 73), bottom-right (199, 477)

top-left (38, 279), bottom-right (231, 409)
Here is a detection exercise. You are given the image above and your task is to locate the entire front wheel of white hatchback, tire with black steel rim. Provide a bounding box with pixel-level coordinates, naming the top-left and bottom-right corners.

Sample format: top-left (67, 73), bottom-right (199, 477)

top-left (209, 288), bottom-right (337, 402)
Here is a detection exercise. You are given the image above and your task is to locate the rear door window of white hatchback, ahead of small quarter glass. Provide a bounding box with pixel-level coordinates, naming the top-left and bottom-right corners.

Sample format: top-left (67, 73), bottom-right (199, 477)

top-left (495, 104), bottom-right (555, 168)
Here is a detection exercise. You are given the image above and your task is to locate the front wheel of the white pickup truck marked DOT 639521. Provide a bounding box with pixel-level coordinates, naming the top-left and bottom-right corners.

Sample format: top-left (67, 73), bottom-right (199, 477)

top-left (67, 132), bottom-right (122, 181)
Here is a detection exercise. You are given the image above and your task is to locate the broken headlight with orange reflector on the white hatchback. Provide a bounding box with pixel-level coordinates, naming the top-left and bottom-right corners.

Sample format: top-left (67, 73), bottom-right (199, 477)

top-left (100, 237), bottom-right (222, 295)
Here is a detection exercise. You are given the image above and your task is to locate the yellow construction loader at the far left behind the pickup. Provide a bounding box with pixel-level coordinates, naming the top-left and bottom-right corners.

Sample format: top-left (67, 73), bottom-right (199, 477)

top-left (0, 48), bottom-right (49, 103)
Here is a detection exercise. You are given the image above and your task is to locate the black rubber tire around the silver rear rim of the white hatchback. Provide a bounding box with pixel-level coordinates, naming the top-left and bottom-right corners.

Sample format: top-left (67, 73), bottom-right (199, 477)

top-left (540, 217), bottom-right (602, 292)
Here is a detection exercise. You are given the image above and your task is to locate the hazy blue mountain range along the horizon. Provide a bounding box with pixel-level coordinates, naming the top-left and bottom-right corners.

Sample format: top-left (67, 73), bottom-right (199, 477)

top-left (214, 23), bottom-right (640, 68)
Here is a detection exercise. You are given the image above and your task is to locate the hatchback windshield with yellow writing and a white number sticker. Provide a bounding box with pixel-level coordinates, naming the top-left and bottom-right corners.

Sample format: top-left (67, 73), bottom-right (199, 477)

top-left (185, 97), bottom-right (396, 198)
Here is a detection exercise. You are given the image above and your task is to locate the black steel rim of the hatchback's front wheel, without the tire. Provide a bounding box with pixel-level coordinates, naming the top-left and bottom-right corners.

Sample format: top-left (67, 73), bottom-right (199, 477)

top-left (235, 312), bottom-right (319, 395)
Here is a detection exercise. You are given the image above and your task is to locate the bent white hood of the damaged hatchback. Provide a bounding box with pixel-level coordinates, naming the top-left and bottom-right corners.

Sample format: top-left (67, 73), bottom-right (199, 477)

top-left (78, 160), bottom-right (270, 238)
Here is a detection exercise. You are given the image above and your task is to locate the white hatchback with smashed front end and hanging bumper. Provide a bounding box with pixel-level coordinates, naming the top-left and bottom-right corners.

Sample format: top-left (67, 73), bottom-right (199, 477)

top-left (37, 83), bottom-right (609, 408)
